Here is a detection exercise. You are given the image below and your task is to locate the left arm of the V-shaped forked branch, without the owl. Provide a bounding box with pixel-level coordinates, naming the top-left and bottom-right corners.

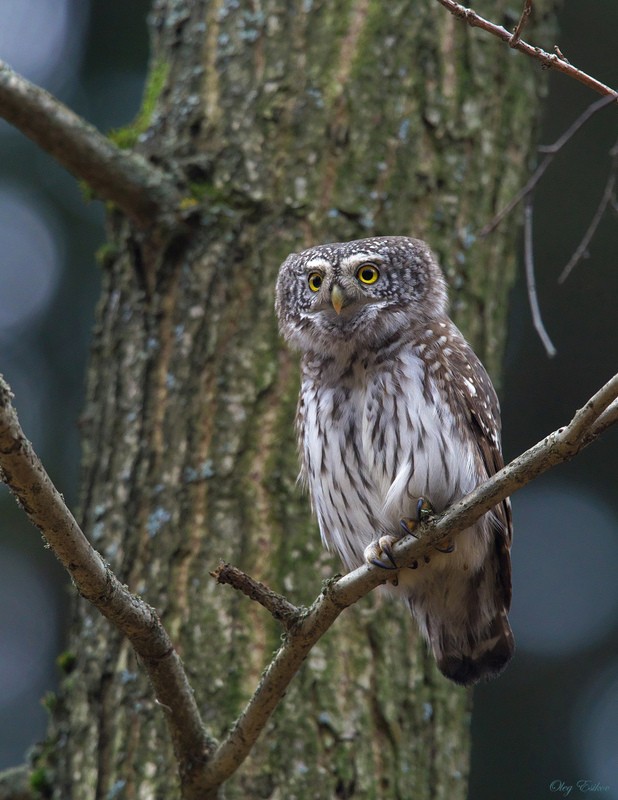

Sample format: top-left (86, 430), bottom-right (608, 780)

top-left (0, 376), bottom-right (216, 800)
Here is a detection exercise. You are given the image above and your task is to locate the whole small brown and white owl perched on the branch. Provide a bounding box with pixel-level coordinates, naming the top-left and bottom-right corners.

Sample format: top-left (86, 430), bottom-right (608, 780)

top-left (276, 236), bottom-right (514, 686)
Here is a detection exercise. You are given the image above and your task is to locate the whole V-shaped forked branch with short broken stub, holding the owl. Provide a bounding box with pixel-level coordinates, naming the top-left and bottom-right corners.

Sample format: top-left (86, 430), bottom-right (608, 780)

top-left (0, 375), bottom-right (618, 800)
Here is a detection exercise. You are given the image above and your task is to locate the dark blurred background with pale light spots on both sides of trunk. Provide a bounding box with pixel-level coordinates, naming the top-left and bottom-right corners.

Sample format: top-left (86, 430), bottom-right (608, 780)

top-left (0, 0), bottom-right (618, 800)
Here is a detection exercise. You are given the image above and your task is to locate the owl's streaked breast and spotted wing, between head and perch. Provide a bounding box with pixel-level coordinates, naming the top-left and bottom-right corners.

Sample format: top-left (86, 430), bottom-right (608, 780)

top-left (298, 321), bottom-right (510, 544)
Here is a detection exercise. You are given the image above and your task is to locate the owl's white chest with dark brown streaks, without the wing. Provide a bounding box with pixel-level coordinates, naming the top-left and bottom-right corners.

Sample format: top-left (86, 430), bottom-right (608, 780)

top-left (299, 352), bottom-right (477, 567)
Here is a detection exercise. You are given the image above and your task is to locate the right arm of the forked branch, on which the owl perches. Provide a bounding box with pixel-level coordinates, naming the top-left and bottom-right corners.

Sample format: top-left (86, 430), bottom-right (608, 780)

top-left (205, 375), bottom-right (618, 796)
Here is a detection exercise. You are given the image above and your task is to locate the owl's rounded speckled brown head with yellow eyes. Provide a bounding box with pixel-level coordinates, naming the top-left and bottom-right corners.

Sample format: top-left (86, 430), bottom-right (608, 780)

top-left (275, 236), bottom-right (447, 355)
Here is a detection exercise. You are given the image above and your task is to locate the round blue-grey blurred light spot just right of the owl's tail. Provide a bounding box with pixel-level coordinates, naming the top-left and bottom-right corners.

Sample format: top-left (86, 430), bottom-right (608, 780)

top-left (511, 483), bottom-right (618, 656)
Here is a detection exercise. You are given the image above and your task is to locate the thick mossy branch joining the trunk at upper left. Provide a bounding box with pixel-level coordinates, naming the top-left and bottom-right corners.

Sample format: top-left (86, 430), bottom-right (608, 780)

top-left (0, 61), bottom-right (181, 227)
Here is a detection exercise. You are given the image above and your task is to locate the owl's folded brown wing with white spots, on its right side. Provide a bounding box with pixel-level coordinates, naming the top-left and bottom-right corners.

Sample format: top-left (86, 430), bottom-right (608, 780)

top-left (442, 337), bottom-right (513, 607)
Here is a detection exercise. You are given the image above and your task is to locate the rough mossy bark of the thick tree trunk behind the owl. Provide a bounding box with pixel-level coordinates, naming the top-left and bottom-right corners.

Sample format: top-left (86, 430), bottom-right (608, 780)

top-left (39, 0), bottom-right (556, 800)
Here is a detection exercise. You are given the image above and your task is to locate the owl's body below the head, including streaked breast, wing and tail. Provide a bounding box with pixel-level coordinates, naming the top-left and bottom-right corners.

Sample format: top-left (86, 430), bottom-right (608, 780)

top-left (297, 318), bottom-right (513, 685)
